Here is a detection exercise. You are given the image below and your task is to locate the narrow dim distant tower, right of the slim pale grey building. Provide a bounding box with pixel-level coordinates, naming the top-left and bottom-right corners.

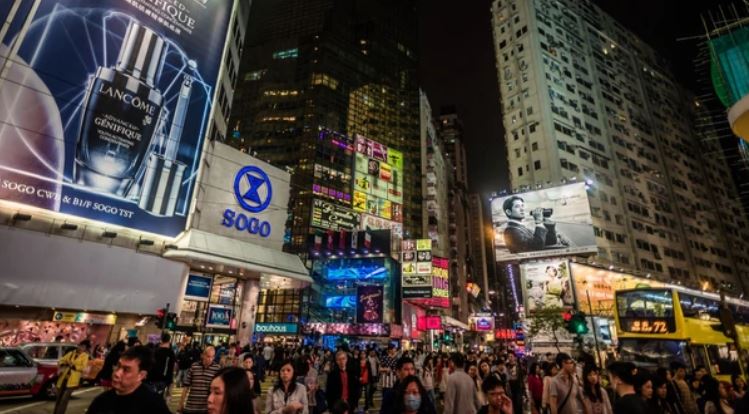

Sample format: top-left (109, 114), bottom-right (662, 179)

top-left (438, 106), bottom-right (471, 321)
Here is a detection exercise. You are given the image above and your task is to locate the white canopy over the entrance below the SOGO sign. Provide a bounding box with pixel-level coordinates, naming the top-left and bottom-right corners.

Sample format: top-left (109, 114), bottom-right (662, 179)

top-left (164, 229), bottom-right (312, 285)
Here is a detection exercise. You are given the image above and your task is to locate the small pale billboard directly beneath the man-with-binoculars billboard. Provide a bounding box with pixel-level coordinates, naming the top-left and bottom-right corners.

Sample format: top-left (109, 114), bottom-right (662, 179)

top-left (520, 259), bottom-right (575, 312)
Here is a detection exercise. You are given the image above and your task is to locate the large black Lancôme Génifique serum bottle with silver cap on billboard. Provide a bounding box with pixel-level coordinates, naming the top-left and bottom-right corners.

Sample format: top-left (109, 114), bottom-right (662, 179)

top-left (74, 20), bottom-right (165, 196)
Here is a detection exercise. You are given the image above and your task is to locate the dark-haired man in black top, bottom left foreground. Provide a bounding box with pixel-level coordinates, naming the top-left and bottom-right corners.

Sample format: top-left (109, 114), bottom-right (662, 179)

top-left (86, 346), bottom-right (170, 414)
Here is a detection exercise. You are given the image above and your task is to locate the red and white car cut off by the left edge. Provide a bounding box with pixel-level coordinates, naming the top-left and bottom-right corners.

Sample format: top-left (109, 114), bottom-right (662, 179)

top-left (0, 347), bottom-right (57, 398)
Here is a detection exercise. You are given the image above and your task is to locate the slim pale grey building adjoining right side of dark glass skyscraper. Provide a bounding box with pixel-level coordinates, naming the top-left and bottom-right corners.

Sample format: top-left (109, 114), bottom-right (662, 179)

top-left (419, 92), bottom-right (450, 257)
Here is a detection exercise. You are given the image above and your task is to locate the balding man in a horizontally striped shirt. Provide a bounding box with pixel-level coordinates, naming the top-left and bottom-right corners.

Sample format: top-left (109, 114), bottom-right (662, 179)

top-left (177, 346), bottom-right (221, 414)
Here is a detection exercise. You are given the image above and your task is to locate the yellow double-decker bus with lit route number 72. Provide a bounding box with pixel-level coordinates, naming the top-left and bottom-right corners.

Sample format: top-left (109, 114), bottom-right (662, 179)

top-left (614, 285), bottom-right (749, 379)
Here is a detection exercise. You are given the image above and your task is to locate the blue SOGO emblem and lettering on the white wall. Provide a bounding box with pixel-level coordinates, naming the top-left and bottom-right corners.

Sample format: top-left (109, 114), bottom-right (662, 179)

top-left (221, 165), bottom-right (273, 237)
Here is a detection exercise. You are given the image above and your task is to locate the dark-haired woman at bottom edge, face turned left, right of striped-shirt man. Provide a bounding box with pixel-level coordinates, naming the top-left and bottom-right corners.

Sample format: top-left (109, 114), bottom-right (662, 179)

top-left (207, 368), bottom-right (255, 414)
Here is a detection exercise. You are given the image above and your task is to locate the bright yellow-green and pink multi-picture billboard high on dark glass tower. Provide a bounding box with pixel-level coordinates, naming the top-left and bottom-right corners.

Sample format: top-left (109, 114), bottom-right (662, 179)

top-left (353, 135), bottom-right (403, 223)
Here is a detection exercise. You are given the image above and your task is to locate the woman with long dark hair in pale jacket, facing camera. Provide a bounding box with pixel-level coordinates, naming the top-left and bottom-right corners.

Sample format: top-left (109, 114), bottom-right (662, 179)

top-left (264, 360), bottom-right (309, 414)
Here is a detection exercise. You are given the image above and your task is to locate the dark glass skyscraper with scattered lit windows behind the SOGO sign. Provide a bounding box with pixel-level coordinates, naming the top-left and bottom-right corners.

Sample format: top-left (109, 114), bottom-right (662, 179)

top-left (227, 0), bottom-right (422, 251)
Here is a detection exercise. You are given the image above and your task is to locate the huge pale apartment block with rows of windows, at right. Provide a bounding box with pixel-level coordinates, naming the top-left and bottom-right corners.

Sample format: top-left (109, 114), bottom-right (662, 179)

top-left (492, 0), bottom-right (749, 291)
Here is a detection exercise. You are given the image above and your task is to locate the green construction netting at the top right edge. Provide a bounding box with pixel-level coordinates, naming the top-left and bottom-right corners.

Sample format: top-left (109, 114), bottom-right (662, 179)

top-left (709, 26), bottom-right (749, 107)
